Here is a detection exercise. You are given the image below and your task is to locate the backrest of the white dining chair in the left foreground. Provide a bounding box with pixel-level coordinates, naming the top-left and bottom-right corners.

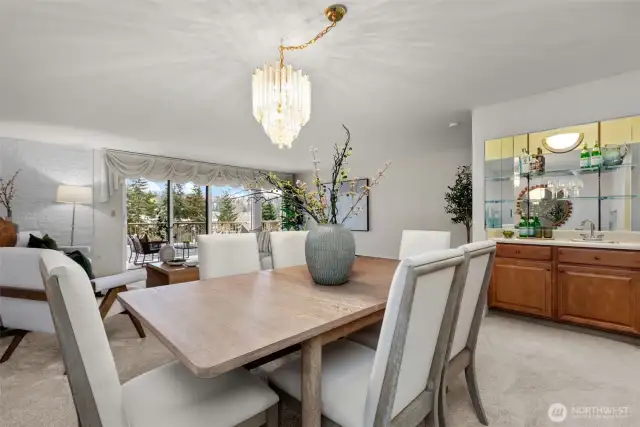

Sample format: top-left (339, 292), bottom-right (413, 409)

top-left (40, 250), bottom-right (128, 427)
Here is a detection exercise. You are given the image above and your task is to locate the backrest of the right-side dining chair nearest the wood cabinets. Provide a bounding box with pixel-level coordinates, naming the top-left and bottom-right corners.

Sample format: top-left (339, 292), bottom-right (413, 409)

top-left (451, 240), bottom-right (496, 358)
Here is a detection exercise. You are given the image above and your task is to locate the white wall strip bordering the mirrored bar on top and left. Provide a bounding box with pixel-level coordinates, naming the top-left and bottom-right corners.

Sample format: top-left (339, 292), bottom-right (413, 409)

top-left (472, 70), bottom-right (640, 240)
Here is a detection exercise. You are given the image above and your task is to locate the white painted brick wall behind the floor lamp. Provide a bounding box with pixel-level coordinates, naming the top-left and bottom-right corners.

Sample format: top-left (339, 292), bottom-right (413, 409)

top-left (0, 137), bottom-right (126, 276)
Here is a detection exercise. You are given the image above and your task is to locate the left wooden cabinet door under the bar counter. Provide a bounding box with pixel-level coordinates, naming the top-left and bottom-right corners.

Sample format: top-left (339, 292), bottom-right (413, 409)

top-left (489, 258), bottom-right (552, 318)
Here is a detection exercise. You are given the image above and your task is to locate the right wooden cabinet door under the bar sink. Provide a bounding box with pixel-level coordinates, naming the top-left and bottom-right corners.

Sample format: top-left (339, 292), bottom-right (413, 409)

top-left (558, 264), bottom-right (640, 334)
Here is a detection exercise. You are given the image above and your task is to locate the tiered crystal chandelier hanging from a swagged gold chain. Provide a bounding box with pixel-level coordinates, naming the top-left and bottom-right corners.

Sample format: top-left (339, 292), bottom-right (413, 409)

top-left (252, 4), bottom-right (347, 148)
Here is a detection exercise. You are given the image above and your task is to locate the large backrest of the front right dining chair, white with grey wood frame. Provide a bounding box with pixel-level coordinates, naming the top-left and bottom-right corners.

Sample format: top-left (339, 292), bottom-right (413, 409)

top-left (364, 249), bottom-right (468, 427)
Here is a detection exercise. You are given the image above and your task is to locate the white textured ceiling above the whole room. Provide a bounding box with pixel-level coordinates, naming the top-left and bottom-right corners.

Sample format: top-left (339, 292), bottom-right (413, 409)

top-left (0, 0), bottom-right (640, 171)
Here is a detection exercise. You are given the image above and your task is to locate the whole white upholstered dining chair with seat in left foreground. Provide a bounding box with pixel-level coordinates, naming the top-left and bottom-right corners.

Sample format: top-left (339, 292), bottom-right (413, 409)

top-left (40, 250), bottom-right (278, 427)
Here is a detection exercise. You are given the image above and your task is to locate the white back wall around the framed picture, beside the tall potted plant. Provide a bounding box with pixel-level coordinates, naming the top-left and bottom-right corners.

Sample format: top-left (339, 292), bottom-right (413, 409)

top-left (298, 123), bottom-right (471, 258)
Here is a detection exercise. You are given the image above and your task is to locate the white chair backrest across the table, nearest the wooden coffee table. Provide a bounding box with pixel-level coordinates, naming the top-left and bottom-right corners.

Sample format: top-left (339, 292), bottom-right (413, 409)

top-left (198, 233), bottom-right (260, 280)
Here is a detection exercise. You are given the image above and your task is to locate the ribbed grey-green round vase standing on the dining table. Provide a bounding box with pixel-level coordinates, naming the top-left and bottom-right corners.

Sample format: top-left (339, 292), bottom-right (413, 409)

top-left (305, 224), bottom-right (356, 286)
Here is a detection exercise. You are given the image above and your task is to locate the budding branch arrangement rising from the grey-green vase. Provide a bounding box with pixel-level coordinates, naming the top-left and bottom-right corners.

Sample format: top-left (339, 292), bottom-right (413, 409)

top-left (263, 125), bottom-right (391, 224)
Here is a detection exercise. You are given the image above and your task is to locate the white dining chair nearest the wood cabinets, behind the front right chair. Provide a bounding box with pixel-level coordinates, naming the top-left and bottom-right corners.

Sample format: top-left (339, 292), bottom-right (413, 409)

top-left (440, 240), bottom-right (496, 427)
